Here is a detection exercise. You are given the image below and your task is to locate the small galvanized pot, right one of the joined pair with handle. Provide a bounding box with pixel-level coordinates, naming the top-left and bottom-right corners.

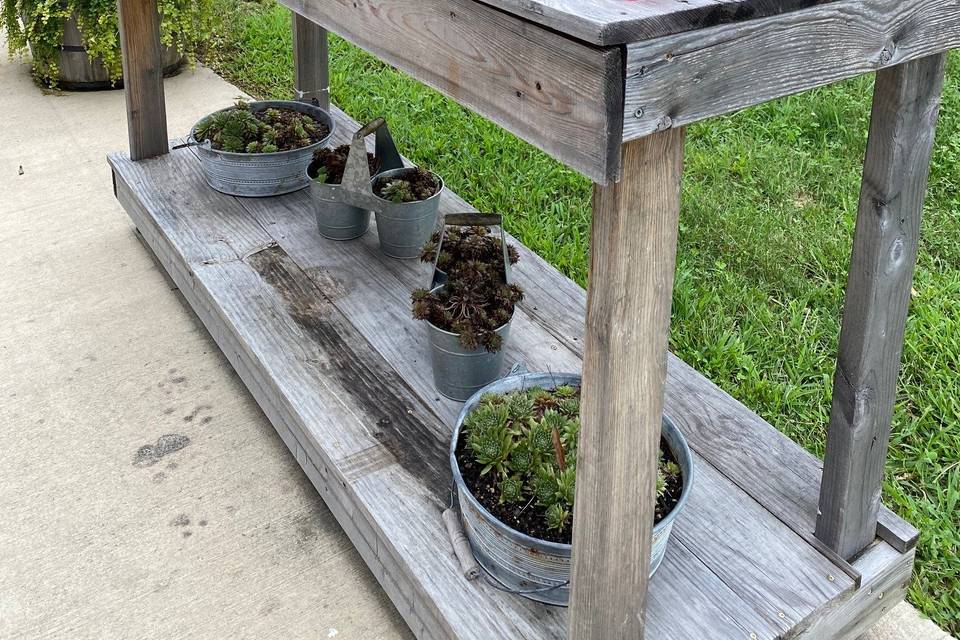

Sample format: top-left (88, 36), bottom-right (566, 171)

top-left (370, 168), bottom-right (444, 259)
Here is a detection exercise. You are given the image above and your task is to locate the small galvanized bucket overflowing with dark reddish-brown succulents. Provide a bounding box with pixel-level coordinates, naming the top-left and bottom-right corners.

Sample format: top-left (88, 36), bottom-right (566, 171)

top-left (426, 285), bottom-right (513, 402)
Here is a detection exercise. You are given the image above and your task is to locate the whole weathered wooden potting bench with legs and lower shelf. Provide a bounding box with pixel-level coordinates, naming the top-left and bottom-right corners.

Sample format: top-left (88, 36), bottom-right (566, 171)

top-left (110, 0), bottom-right (960, 640)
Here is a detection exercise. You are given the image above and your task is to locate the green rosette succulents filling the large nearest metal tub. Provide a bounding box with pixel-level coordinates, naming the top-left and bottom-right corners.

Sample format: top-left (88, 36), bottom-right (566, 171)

top-left (461, 385), bottom-right (681, 533)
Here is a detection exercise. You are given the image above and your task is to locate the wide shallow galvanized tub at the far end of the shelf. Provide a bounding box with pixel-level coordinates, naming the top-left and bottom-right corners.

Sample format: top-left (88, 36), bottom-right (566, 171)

top-left (188, 100), bottom-right (335, 198)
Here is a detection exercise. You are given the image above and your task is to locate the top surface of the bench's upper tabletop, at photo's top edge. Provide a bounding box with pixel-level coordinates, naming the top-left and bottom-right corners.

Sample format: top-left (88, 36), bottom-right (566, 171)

top-left (476, 0), bottom-right (844, 45)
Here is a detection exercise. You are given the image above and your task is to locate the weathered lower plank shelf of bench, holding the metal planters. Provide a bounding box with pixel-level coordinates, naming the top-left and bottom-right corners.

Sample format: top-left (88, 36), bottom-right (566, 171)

top-left (109, 102), bottom-right (917, 640)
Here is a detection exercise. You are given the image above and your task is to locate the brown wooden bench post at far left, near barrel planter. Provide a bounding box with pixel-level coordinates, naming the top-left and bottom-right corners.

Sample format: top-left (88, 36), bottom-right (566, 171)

top-left (117, 0), bottom-right (167, 160)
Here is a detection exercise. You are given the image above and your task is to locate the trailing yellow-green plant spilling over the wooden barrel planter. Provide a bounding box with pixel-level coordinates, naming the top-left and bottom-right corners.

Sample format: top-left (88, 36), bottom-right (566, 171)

top-left (0, 0), bottom-right (214, 86)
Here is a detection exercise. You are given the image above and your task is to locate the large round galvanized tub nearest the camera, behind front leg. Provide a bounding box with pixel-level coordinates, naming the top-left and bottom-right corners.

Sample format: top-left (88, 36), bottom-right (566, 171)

top-left (450, 373), bottom-right (693, 606)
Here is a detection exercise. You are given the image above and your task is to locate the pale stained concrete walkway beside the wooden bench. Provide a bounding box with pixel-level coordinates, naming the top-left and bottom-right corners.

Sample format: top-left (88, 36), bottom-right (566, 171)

top-left (0, 46), bottom-right (948, 640)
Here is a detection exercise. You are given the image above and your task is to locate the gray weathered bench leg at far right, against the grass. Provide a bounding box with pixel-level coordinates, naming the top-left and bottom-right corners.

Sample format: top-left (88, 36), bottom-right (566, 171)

top-left (816, 54), bottom-right (946, 558)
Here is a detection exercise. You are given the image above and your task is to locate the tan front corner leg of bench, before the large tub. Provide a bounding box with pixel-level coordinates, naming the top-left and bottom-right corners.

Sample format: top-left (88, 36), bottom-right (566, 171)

top-left (568, 129), bottom-right (684, 640)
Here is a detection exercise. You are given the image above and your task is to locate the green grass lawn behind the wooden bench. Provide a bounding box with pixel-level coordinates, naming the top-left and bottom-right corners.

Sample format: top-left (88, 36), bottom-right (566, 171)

top-left (206, 0), bottom-right (960, 634)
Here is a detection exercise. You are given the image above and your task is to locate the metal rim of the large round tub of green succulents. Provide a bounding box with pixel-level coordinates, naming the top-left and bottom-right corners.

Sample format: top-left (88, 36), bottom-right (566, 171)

top-left (450, 372), bottom-right (695, 555)
